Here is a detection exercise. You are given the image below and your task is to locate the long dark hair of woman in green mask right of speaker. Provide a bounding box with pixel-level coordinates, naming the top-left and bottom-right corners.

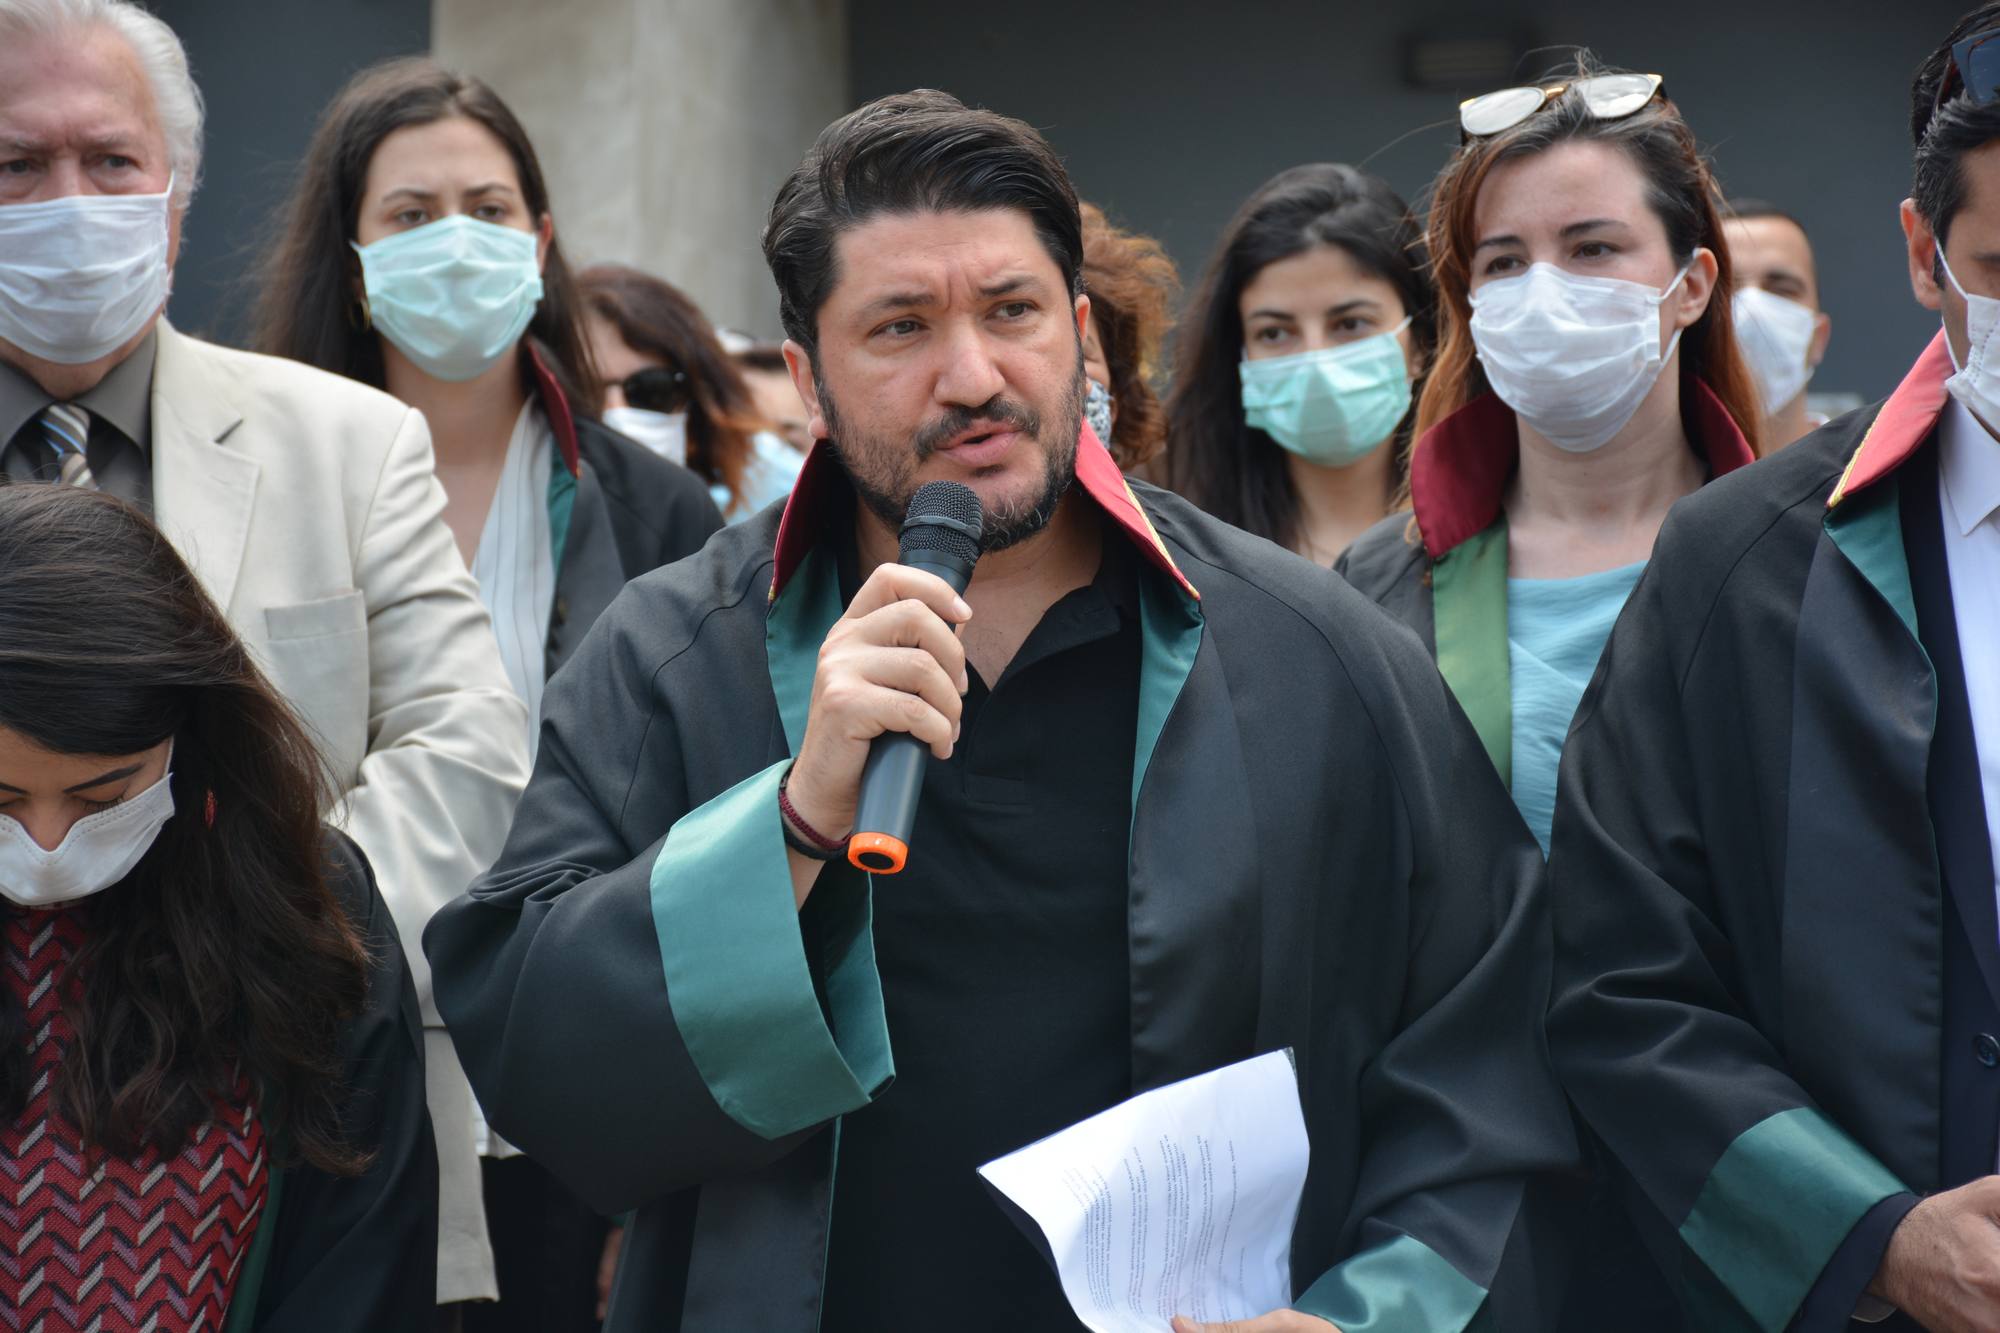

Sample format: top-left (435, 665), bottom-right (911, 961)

top-left (1166, 162), bottom-right (1438, 546)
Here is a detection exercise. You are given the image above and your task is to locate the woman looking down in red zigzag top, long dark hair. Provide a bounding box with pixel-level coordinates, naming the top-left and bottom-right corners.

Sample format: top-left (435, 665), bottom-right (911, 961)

top-left (0, 486), bottom-right (438, 1333)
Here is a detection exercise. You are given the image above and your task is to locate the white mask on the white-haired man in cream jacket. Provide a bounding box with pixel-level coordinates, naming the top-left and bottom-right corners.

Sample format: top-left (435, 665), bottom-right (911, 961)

top-left (0, 182), bottom-right (174, 366)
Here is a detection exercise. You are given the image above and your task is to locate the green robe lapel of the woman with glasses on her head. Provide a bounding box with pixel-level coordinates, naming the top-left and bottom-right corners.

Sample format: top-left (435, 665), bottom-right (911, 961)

top-left (1430, 516), bottom-right (1514, 791)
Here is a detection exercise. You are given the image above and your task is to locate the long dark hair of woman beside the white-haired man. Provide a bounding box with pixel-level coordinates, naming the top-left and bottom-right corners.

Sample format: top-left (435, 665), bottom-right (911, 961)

top-left (250, 56), bottom-right (602, 416)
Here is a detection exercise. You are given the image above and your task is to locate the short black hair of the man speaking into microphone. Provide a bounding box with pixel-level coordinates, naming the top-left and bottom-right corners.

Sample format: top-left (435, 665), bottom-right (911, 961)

top-left (764, 88), bottom-right (1084, 352)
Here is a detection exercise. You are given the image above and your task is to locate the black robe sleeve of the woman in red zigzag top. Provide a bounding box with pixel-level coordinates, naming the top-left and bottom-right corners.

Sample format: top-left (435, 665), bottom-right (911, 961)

top-left (252, 835), bottom-right (438, 1333)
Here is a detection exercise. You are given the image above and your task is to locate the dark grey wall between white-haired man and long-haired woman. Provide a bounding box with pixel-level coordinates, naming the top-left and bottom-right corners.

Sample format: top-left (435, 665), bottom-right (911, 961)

top-left (152, 0), bottom-right (430, 342)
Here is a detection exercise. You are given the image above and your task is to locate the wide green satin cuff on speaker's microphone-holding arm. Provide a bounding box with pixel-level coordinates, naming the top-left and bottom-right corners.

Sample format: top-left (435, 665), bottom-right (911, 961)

top-left (652, 761), bottom-right (896, 1139)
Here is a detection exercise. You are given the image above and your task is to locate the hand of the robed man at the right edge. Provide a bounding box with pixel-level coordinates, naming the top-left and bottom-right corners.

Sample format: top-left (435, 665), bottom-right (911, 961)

top-left (1868, 1175), bottom-right (2000, 1333)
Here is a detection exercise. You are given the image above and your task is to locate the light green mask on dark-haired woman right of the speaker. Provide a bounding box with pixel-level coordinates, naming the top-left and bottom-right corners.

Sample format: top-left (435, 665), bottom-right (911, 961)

top-left (1236, 320), bottom-right (1410, 468)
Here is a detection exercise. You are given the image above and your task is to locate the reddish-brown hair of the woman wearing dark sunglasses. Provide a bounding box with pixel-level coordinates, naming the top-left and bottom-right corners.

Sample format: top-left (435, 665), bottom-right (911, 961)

top-left (576, 264), bottom-right (760, 508)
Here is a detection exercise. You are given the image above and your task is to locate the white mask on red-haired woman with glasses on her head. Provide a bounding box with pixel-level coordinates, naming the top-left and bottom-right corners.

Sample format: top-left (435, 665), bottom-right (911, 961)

top-left (1472, 260), bottom-right (1692, 454)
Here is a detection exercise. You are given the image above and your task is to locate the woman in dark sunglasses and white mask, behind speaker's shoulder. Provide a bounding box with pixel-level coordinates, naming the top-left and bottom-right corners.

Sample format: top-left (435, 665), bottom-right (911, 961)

top-left (578, 264), bottom-right (804, 522)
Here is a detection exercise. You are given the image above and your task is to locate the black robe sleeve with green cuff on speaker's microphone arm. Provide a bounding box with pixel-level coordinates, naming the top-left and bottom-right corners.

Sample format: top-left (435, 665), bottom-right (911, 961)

top-left (424, 564), bottom-right (888, 1215)
